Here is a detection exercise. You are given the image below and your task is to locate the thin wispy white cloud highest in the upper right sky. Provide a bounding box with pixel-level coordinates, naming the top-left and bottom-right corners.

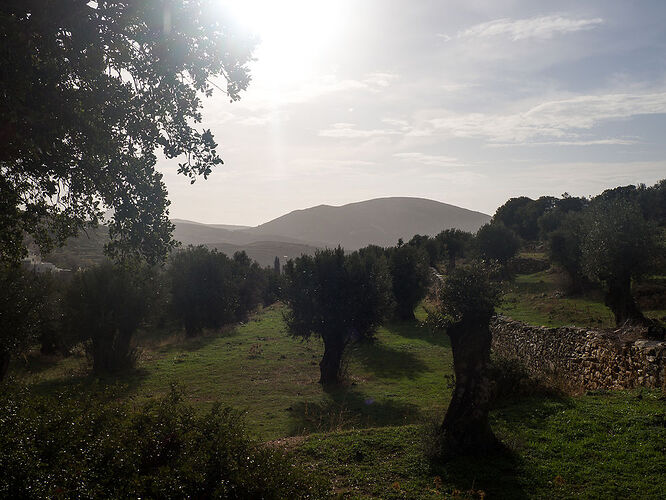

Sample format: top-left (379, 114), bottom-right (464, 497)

top-left (458, 15), bottom-right (604, 41)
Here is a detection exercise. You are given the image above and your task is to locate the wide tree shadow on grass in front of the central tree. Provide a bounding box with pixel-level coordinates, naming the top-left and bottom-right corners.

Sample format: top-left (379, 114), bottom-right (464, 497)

top-left (288, 388), bottom-right (422, 436)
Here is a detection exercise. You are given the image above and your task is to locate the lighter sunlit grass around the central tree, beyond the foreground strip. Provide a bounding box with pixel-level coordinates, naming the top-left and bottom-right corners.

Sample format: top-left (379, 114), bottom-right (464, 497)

top-left (14, 305), bottom-right (452, 439)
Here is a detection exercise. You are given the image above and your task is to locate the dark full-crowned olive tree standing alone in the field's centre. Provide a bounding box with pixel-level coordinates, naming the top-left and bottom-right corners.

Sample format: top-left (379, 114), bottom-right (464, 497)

top-left (284, 247), bottom-right (392, 385)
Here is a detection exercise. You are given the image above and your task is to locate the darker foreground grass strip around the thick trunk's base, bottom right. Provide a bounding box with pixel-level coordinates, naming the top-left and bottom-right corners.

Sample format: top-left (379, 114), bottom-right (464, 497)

top-left (295, 391), bottom-right (666, 499)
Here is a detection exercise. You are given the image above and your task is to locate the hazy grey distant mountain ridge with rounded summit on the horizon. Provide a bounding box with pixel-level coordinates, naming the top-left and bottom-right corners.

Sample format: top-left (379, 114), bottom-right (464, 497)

top-left (43, 198), bottom-right (490, 269)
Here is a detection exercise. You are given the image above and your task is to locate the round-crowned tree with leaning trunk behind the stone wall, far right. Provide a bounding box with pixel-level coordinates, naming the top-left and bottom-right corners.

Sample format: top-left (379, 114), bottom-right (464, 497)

top-left (581, 197), bottom-right (664, 325)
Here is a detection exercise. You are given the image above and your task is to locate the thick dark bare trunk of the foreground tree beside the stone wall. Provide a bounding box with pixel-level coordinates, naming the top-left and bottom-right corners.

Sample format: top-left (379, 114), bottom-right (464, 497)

top-left (441, 318), bottom-right (498, 455)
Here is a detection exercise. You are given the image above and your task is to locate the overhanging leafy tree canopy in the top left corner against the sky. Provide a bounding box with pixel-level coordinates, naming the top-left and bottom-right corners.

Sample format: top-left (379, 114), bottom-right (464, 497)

top-left (0, 0), bottom-right (254, 262)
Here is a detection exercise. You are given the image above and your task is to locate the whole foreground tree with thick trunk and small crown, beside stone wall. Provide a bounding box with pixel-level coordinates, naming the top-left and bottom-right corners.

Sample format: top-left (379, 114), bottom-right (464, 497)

top-left (429, 262), bottom-right (500, 455)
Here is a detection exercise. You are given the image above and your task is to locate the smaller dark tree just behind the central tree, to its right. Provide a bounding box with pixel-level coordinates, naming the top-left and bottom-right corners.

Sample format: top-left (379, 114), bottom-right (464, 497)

top-left (387, 245), bottom-right (430, 320)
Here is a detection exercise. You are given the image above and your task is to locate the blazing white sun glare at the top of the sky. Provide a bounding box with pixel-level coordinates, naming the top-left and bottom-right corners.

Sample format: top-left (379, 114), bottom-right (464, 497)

top-left (220, 0), bottom-right (349, 86)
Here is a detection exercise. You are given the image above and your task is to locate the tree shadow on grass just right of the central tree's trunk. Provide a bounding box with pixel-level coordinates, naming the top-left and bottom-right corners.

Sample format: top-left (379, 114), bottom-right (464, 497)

top-left (352, 342), bottom-right (428, 379)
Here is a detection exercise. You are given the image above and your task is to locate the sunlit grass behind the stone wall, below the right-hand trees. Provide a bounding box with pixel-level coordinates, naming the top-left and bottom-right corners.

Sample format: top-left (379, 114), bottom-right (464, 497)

top-left (498, 270), bottom-right (666, 328)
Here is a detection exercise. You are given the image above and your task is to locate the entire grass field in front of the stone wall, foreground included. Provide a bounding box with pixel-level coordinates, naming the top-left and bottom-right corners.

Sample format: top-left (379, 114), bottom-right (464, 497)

top-left (12, 298), bottom-right (666, 498)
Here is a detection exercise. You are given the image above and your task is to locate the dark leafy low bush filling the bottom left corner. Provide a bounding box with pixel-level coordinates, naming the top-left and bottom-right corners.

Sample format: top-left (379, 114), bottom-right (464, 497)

top-left (0, 389), bottom-right (327, 499)
